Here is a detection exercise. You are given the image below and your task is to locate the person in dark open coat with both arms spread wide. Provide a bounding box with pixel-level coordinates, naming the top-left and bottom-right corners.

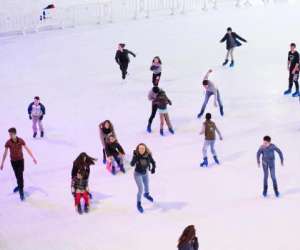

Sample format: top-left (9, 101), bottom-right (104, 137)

top-left (220, 27), bottom-right (247, 67)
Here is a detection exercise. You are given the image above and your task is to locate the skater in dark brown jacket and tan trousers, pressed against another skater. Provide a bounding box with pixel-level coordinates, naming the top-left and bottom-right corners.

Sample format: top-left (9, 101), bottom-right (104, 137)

top-left (154, 89), bottom-right (174, 136)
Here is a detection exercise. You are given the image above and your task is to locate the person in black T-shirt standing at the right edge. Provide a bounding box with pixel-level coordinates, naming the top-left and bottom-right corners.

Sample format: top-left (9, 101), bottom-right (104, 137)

top-left (284, 43), bottom-right (299, 97)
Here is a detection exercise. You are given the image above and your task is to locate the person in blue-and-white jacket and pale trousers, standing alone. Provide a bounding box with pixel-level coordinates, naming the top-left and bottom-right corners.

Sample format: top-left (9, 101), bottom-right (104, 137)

top-left (28, 96), bottom-right (46, 138)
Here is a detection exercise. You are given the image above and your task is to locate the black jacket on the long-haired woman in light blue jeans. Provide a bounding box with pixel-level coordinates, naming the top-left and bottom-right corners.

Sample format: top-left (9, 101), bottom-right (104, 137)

top-left (130, 152), bottom-right (156, 174)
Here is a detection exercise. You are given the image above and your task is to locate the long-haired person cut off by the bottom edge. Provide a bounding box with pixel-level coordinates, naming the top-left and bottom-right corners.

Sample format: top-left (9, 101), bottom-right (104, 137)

top-left (177, 225), bottom-right (199, 250)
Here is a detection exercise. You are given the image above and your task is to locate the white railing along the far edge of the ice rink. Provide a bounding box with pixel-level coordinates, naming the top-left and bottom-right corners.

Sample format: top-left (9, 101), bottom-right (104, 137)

top-left (0, 0), bottom-right (288, 35)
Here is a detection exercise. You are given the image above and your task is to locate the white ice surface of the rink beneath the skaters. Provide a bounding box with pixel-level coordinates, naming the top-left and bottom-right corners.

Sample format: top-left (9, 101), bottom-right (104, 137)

top-left (0, 4), bottom-right (300, 250)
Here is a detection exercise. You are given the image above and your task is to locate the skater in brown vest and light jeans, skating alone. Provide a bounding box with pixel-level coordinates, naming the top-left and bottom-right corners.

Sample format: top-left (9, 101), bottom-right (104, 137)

top-left (200, 113), bottom-right (223, 167)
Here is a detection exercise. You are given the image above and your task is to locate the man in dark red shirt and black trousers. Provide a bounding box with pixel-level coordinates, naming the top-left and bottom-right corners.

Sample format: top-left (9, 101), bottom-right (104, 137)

top-left (0, 128), bottom-right (37, 201)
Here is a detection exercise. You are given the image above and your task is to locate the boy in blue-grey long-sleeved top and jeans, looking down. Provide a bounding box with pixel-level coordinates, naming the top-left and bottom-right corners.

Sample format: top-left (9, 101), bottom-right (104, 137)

top-left (256, 136), bottom-right (284, 197)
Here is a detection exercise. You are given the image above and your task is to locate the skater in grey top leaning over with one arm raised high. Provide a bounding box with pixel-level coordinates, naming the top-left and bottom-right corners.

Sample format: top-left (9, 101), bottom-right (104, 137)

top-left (197, 69), bottom-right (224, 118)
